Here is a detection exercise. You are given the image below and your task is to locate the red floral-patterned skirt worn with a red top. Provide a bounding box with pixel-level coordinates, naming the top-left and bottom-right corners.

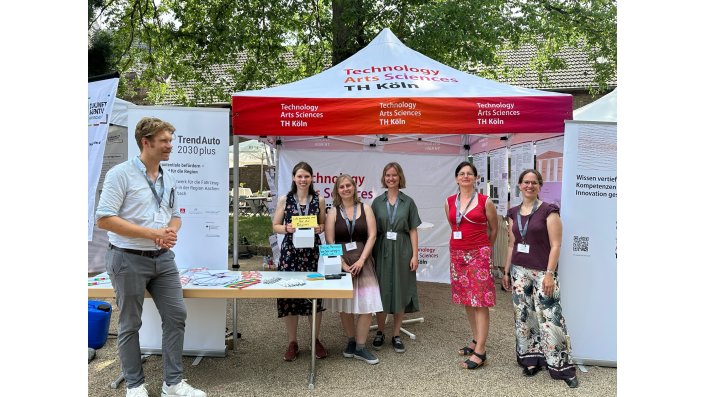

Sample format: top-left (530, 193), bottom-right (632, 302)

top-left (450, 246), bottom-right (496, 307)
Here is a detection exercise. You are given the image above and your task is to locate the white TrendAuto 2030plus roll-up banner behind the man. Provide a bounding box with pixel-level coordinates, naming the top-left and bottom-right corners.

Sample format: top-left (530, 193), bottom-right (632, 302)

top-left (128, 106), bottom-right (230, 356)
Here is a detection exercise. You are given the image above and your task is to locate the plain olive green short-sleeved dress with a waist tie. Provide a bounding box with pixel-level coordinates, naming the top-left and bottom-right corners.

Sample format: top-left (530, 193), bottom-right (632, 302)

top-left (372, 192), bottom-right (421, 314)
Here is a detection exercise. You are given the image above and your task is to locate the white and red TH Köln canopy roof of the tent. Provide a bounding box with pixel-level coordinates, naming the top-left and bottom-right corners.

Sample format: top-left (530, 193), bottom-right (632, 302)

top-left (232, 29), bottom-right (573, 136)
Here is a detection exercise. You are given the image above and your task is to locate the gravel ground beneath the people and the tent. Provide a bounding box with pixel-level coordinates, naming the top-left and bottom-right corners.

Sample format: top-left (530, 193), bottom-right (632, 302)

top-left (88, 257), bottom-right (617, 397)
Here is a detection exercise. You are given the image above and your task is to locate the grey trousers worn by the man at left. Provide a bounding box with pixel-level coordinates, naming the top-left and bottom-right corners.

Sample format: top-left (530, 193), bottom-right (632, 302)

top-left (105, 249), bottom-right (186, 388)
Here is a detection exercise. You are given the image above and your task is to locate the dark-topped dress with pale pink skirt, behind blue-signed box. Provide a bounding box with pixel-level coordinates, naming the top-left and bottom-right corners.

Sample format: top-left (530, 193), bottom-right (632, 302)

top-left (328, 204), bottom-right (382, 314)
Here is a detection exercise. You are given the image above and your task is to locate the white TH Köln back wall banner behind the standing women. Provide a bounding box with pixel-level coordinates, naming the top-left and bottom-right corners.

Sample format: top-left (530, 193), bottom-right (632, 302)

top-left (277, 149), bottom-right (465, 284)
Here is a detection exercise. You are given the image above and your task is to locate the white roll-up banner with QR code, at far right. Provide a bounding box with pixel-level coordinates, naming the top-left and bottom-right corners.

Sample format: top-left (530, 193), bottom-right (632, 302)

top-left (558, 121), bottom-right (617, 366)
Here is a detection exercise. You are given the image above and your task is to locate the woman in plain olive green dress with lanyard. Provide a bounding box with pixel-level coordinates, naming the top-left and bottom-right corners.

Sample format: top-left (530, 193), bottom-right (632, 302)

top-left (372, 162), bottom-right (421, 353)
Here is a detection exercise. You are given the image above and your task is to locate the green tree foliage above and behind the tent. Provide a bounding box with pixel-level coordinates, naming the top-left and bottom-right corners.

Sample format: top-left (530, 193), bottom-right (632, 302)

top-left (89, 0), bottom-right (617, 105)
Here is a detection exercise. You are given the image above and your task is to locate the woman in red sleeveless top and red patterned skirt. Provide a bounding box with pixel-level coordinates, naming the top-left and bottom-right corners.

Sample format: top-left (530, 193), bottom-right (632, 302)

top-left (445, 161), bottom-right (497, 369)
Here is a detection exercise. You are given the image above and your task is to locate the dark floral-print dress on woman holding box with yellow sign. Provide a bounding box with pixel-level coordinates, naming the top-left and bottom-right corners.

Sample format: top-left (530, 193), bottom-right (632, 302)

top-left (277, 192), bottom-right (325, 317)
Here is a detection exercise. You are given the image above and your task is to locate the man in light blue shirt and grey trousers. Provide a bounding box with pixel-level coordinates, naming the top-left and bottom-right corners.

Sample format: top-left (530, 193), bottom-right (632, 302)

top-left (96, 117), bottom-right (206, 397)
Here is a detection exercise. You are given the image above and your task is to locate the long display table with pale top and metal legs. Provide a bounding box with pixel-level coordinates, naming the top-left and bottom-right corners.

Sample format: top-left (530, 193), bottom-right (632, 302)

top-left (88, 270), bottom-right (353, 389)
